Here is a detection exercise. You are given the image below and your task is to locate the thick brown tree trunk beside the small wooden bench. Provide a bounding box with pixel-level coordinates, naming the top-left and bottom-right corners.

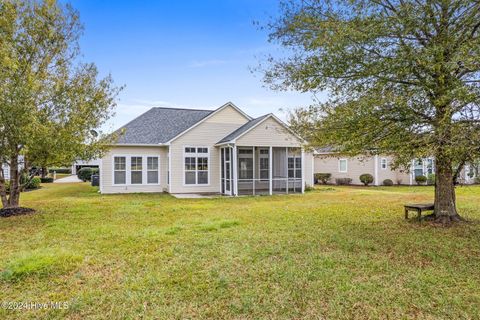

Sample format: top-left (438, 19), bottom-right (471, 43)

top-left (434, 154), bottom-right (463, 224)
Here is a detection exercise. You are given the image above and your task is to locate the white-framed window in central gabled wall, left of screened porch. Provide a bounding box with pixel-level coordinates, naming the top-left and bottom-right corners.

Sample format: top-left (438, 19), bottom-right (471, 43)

top-left (184, 147), bottom-right (209, 185)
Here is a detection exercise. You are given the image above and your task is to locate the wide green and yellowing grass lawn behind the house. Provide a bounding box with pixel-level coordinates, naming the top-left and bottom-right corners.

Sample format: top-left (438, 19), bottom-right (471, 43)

top-left (0, 183), bottom-right (480, 319)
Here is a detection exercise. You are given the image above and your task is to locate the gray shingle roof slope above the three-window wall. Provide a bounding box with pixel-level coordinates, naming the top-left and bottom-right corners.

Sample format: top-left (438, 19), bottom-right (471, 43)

top-left (115, 108), bottom-right (214, 144)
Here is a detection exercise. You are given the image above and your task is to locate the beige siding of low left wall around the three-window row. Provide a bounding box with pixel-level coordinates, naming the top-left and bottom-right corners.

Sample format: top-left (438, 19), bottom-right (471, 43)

top-left (100, 146), bottom-right (168, 193)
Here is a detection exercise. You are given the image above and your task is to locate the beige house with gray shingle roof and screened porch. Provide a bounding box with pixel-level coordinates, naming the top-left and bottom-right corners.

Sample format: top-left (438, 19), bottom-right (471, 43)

top-left (100, 103), bottom-right (313, 195)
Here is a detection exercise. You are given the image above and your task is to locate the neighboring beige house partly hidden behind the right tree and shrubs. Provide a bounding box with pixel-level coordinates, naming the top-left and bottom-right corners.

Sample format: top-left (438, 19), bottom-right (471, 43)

top-left (314, 148), bottom-right (478, 186)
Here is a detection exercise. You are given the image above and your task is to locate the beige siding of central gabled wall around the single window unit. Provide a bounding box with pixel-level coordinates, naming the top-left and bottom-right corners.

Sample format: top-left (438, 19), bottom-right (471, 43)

top-left (170, 106), bottom-right (248, 193)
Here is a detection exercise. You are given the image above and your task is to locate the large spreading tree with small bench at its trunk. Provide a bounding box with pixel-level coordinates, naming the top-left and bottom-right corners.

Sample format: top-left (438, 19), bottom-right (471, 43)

top-left (263, 0), bottom-right (480, 223)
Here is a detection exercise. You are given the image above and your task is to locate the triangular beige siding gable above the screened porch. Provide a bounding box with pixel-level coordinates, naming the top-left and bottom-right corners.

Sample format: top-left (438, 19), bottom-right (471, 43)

top-left (235, 118), bottom-right (302, 147)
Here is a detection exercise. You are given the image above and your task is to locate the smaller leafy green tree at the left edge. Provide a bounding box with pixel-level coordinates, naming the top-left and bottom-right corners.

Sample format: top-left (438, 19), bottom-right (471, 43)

top-left (0, 0), bottom-right (119, 207)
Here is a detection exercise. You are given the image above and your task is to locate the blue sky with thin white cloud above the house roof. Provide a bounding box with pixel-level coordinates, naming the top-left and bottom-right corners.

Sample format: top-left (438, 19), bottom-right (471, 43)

top-left (70, 0), bottom-right (311, 130)
